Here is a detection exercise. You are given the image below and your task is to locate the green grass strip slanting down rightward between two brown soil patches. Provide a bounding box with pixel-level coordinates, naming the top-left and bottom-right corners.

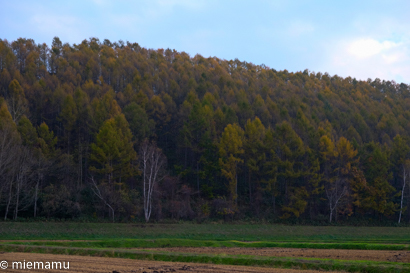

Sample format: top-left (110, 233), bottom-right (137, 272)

top-left (0, 245), bottom-right (410, 273)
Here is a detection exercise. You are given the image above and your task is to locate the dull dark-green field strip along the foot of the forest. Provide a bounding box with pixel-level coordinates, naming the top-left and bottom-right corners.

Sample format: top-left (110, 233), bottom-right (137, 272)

top-left (0, 222), bottom-right (410, 241)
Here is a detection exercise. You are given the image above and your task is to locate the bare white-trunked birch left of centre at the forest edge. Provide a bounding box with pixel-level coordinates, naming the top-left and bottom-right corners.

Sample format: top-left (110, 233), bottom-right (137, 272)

top-left (140, 139), bottom-right (167, 222)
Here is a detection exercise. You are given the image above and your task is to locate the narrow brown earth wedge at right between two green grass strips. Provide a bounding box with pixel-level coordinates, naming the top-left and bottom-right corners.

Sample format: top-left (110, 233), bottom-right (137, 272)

top-left (139, 247), bottom-right (410, 263)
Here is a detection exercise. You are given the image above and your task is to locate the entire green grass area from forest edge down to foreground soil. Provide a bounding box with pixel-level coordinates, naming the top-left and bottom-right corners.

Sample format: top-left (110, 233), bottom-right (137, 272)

top-left (0, 222), bottom-right (410, 272)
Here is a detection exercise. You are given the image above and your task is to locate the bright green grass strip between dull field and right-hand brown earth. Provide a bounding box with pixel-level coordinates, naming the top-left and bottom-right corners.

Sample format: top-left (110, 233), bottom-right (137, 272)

top-left (8, 239), bottom-right (410, 250)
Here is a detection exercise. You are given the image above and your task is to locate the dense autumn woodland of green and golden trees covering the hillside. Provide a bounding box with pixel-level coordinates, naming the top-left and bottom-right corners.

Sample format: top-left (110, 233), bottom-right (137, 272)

top-left (0, 37), bottom-right (410, 223)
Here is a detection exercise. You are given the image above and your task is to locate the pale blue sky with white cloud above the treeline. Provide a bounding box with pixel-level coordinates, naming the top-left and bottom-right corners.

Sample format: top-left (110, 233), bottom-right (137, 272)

top-left (0, 0), bottom-right (410, 84)
